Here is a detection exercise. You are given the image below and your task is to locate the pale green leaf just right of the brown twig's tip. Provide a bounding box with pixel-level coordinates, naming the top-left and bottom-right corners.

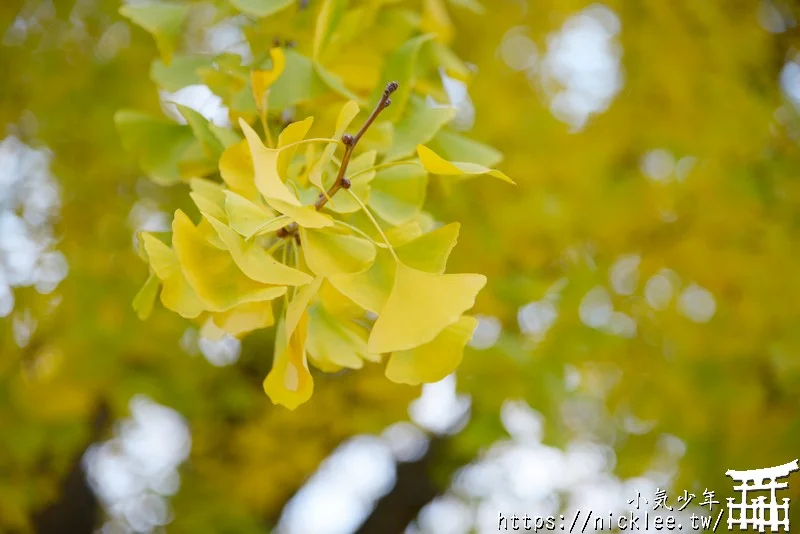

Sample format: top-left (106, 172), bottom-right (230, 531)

top-left (384, 97), bottom-right (455, 161)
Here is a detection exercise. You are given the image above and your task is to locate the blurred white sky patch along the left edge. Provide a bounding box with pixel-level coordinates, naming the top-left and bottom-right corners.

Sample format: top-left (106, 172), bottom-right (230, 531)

top-left (0, 136), bottom-right (69, 317)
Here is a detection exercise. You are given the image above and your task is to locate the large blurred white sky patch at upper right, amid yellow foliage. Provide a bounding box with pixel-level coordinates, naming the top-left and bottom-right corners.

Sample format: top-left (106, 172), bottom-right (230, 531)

top-left (539, 4), bottom-right (624, 132)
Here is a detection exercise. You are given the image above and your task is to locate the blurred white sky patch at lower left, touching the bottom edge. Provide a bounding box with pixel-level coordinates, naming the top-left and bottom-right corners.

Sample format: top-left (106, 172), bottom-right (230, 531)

top-left (83, 396), bottom-right (191, 532)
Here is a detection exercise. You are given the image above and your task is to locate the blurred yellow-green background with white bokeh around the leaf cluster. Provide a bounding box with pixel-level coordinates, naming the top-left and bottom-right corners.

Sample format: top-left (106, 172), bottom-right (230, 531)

top-left (0, 0), bottom-right (800, 534)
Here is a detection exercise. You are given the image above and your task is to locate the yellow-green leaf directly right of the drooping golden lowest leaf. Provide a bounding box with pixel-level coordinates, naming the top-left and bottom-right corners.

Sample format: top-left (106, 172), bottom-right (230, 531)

top-left (306, 306), bottom-right (374, 369)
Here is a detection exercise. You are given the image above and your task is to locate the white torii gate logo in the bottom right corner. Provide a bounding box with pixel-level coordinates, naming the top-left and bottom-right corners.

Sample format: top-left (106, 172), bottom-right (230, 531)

top-left (725, 460), bottom-right (798, 532)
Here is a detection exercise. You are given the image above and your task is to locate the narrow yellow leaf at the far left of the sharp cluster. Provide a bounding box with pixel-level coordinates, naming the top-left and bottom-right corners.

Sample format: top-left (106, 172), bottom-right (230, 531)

top-left (140, 232), bottom-right (205, 319)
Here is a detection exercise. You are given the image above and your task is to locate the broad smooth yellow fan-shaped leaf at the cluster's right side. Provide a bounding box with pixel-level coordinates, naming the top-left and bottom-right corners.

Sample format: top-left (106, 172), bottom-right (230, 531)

top-left (368, 262), bottom-right (486, 353)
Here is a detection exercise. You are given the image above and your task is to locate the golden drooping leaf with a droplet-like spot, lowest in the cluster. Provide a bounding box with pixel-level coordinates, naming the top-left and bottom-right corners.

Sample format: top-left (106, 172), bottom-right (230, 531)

top-left (264, 314), bottom-right (314, 410)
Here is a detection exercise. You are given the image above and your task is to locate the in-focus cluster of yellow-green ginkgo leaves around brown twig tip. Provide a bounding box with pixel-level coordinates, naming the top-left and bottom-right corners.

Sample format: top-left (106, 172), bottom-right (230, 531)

top-left (116, 1), bottom-right (513, 409)
